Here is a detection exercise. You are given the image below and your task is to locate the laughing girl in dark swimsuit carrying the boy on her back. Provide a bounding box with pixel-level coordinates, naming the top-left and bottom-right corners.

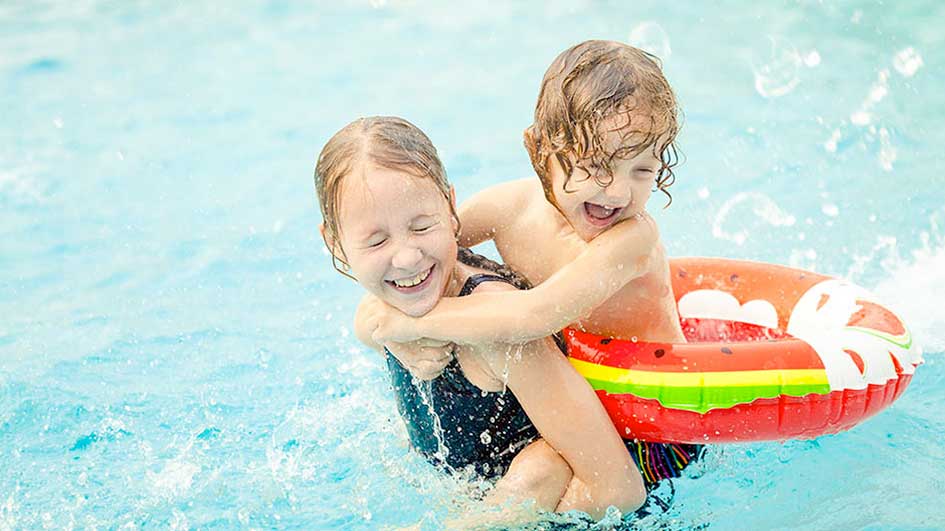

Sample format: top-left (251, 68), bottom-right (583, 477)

top-left (315, 117), bottom-right (646, 517)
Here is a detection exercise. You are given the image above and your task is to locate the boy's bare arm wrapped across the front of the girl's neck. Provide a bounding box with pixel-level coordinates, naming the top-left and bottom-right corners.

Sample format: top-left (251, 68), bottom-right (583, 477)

top-left (374, 214), bottom-right (659, 344)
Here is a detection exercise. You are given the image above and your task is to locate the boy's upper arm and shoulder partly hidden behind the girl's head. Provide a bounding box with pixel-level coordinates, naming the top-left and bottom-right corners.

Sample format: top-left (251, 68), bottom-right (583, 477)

top-left (458, 181), bottom-right (525, 247)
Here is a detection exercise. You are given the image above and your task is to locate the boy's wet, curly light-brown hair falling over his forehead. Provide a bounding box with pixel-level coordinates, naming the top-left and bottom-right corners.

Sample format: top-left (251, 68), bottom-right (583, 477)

top-left (525, 41), bottom-right (680, 206)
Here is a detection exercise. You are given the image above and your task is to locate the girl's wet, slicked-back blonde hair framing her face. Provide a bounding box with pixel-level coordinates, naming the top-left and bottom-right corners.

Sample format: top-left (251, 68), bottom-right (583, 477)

top-left (315, 116), bottom-right (459, 277)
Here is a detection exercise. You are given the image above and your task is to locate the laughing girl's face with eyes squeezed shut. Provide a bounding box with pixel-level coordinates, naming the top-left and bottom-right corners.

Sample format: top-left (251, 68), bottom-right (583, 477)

top-left (338, 164), bottom-right (457, 317)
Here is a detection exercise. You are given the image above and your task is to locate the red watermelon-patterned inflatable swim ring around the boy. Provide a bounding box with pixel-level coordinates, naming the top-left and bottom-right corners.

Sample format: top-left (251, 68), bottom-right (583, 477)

top-left (565, 258), bottom-right (922, 443)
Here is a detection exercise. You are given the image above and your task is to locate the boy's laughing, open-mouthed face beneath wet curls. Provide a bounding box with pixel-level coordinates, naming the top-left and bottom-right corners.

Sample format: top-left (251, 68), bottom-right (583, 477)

top-left (549, 121), bottom-right (662, 241)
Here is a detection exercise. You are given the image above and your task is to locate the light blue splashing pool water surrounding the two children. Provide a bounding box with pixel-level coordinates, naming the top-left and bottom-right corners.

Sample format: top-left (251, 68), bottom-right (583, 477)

top-left (0, 0), bottom-right (945, 530)
